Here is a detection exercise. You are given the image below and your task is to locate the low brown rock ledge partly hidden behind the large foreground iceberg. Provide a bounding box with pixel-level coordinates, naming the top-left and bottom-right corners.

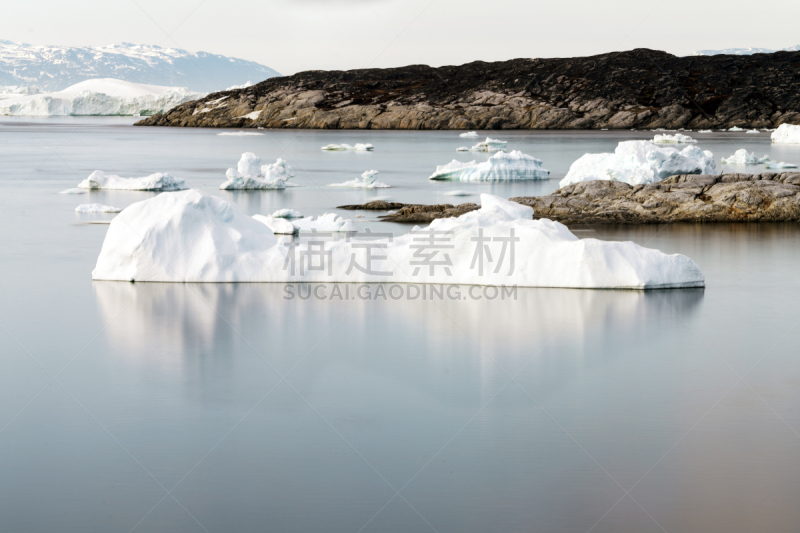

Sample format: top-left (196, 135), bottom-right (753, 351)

top-left (340, 172), bottom-right (800, 225)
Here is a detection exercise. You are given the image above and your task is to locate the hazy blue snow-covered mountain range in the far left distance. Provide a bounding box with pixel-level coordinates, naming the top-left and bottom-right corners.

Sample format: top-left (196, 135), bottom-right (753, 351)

top-left (0, 40), bottom-right (280, 92)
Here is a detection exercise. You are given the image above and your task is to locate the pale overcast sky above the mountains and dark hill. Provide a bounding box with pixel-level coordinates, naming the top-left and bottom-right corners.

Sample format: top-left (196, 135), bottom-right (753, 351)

top-left (0, 0), bottom-right (800, 74)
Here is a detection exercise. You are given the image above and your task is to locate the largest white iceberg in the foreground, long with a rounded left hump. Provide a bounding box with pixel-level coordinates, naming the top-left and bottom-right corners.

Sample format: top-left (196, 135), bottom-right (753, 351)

top-left (92, 190), bottom-right (704, 289)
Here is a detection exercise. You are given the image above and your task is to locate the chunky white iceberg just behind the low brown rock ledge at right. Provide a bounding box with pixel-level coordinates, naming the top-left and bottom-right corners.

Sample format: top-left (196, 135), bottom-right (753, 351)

top-left (559, 141), bottom-right (719, 187)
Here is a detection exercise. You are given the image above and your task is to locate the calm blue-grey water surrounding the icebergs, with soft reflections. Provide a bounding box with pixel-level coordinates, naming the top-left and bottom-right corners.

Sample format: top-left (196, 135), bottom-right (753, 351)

top-left (0, 119), bottom-right (800, 533)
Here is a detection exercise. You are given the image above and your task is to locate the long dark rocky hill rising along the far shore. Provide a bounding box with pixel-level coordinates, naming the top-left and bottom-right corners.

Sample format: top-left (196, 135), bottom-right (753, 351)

top-left (137, 49), bottom-right (800, 129)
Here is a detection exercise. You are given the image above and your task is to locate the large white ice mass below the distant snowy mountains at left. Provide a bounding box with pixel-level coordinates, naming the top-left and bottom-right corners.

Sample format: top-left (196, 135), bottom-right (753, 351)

top-left (0, 78), bottom-right (205, 116)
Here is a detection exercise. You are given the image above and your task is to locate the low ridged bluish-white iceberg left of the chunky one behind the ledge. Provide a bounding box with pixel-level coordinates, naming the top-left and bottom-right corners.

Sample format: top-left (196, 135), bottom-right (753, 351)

top-left (430, 150), bottom-right (550, 181)
